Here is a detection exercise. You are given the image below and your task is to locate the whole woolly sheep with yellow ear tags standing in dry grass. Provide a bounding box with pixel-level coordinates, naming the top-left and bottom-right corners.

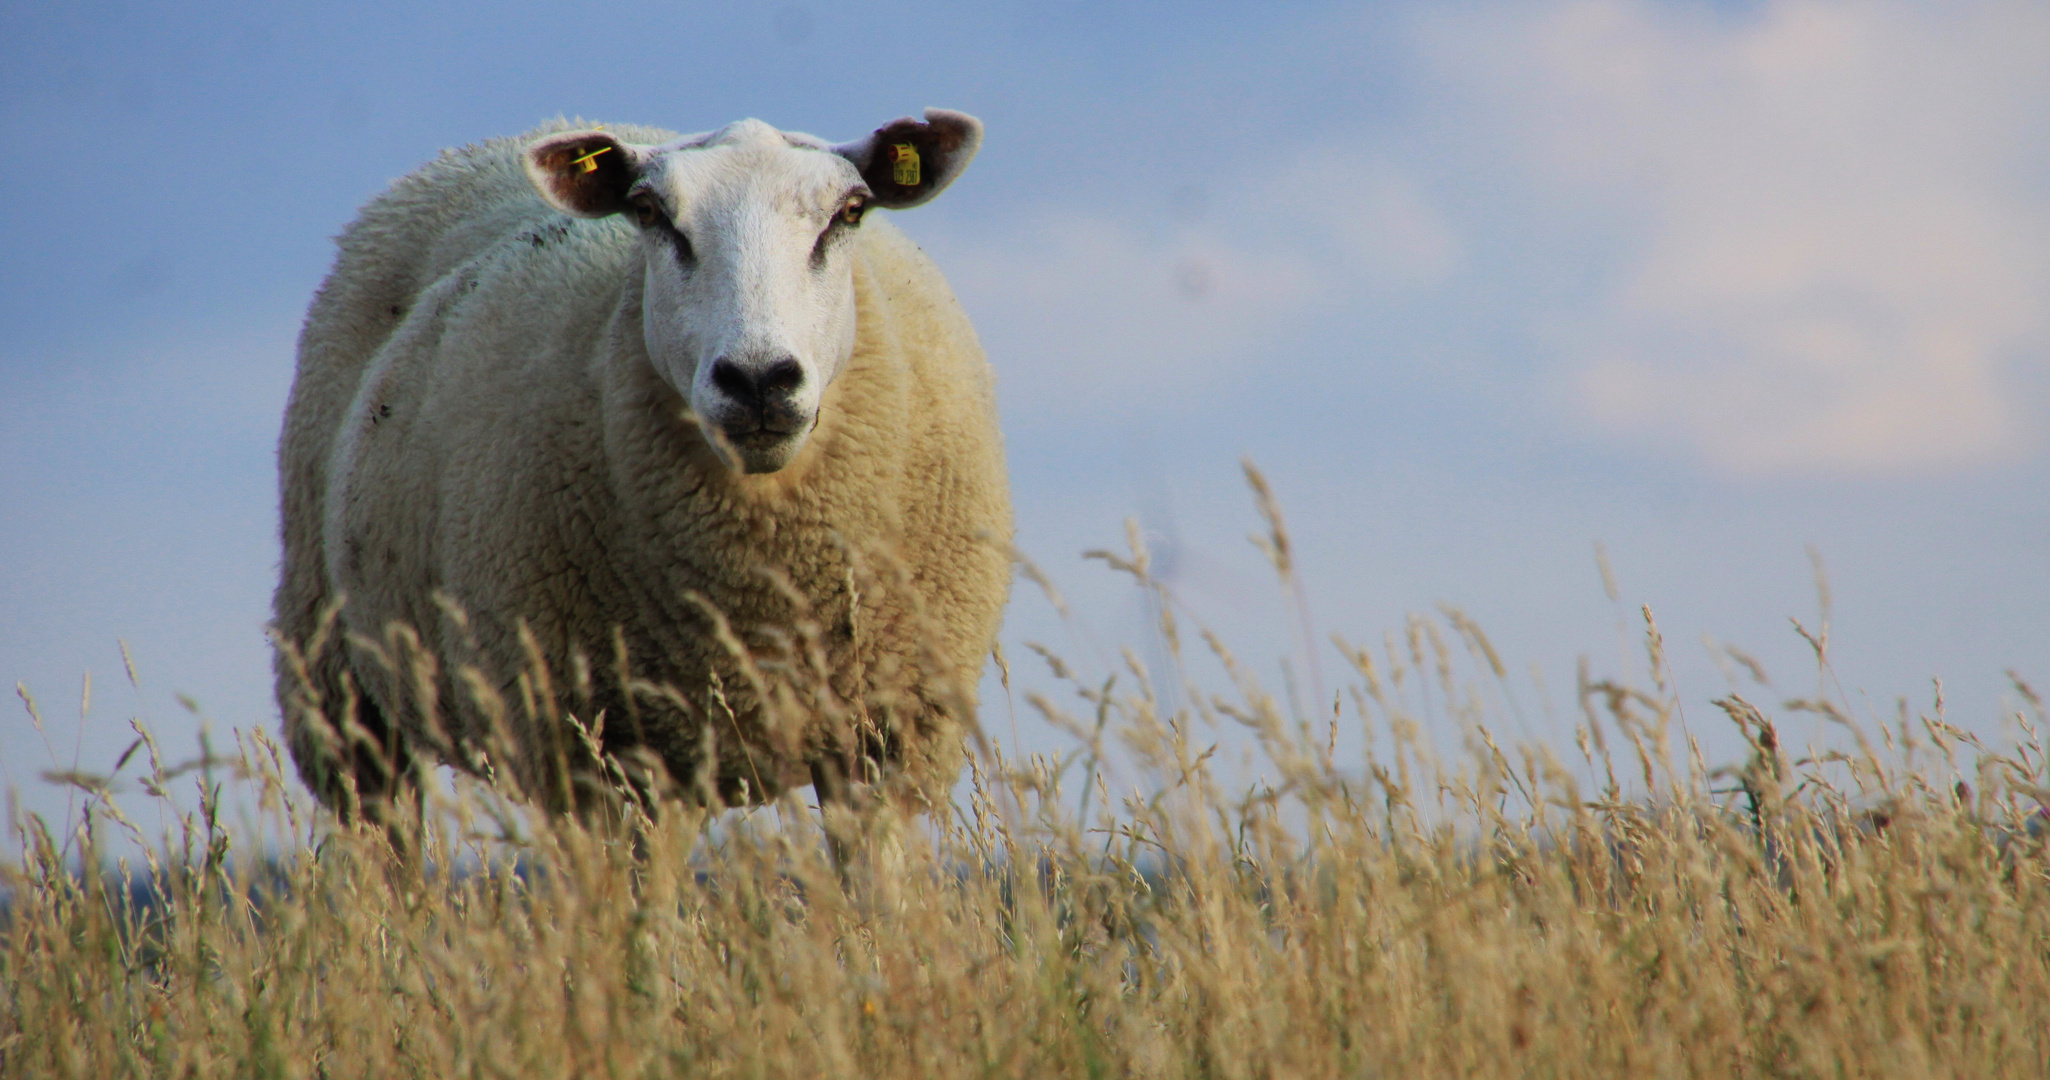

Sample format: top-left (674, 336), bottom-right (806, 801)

top-left (273, 109), bottom-right (1011, 820)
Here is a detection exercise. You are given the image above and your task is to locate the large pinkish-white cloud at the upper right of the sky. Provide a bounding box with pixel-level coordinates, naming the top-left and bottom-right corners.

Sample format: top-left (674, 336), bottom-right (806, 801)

top-left (1427, 0), bottom-right (2050, 473)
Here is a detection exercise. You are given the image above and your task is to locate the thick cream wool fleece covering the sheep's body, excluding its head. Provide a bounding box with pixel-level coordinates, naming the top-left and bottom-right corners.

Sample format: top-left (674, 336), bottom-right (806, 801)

top-left (275, 127), bottom-right (1011, 805)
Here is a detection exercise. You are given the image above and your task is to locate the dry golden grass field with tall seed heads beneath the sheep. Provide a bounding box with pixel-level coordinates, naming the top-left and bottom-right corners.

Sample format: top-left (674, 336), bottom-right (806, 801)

top-left (0, 485), bottom-right (2050, 1080)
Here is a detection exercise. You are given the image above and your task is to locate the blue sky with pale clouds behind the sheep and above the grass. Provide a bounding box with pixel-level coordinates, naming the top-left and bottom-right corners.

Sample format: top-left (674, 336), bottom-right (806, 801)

top-left (0, 0), bottom-right (2050, 840)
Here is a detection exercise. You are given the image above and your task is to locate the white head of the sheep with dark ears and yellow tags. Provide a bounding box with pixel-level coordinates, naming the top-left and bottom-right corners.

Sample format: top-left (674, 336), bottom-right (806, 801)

top-left (527, 109), bottom-right (982, 473)
